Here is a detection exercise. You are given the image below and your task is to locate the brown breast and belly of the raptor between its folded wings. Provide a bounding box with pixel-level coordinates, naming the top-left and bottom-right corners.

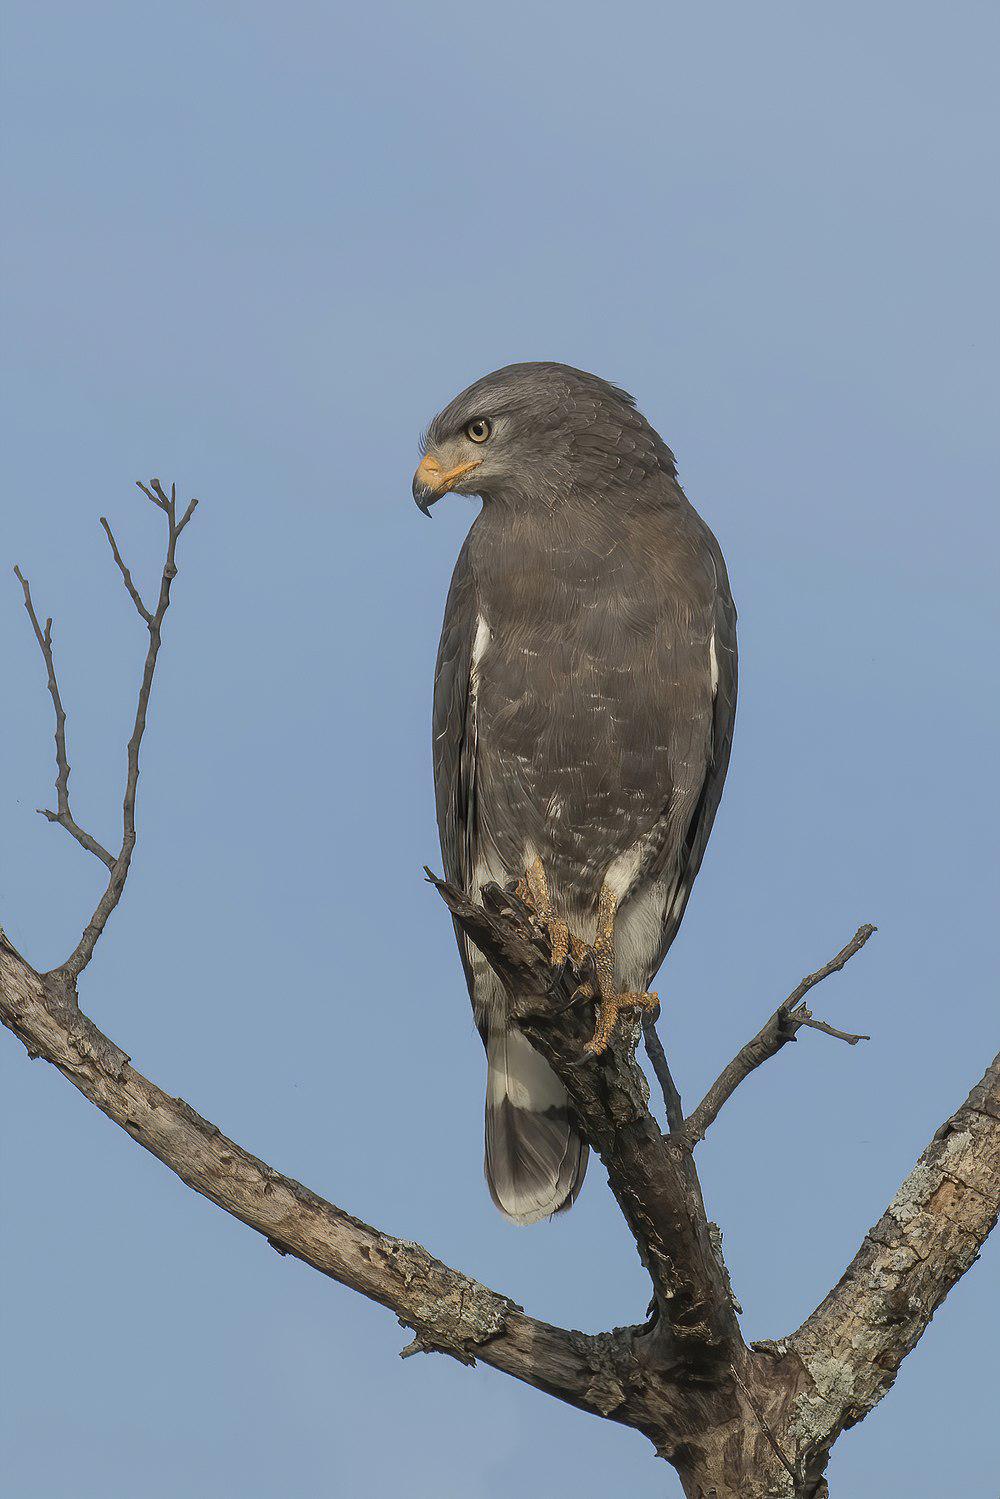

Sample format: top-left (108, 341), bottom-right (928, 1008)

top-left (471, 527), bottom-right (683, 911)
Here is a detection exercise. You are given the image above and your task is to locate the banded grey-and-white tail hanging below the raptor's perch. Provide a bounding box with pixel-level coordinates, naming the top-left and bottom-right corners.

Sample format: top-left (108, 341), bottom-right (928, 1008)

top-left (486, 1027), bottom-right (588, 1223)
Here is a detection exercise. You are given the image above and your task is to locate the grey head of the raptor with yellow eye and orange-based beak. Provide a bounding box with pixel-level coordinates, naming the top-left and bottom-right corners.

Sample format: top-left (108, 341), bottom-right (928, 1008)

top-left (414, 364), bottom-right (675, 516)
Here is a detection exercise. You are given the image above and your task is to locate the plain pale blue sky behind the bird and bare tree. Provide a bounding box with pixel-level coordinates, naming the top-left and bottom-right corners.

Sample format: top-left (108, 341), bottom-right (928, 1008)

top-left (0, 0), bottom-right (1000, 1499)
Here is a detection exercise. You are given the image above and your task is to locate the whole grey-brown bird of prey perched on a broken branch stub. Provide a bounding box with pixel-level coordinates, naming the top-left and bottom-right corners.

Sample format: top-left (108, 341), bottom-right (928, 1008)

top-left (414, 363), bottom-right (736, 1223)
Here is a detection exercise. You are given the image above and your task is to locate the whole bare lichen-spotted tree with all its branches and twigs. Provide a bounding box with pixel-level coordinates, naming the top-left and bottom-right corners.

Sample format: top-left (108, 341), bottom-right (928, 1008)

top-left (0, 480), bottom-right (1000, 1499)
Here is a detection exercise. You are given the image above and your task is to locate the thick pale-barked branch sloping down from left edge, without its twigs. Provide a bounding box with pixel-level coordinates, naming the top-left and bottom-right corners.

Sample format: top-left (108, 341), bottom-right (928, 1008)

top-left (0, 931), bottom-right (652, 1427)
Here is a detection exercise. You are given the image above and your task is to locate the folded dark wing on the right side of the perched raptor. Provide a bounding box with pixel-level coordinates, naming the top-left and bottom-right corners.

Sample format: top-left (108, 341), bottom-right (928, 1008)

top-left (649, 532), bottom-right (738, 979)
